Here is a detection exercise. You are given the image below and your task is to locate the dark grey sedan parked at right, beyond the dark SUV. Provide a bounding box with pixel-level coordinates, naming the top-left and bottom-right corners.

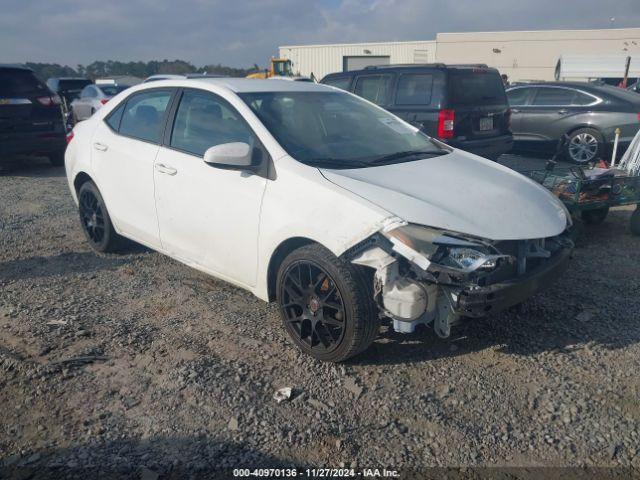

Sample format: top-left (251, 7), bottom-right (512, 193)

top-left (507, 82), bottom-right (640, 164)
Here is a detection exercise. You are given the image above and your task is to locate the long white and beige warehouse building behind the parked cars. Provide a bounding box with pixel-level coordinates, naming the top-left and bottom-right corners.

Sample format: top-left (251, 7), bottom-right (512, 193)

top-left (280, 28), bottom-right (640, 80)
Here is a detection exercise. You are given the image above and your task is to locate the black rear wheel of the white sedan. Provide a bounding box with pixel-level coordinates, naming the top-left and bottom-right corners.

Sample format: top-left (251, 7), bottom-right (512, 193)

top-left (78, 181), bottom-right (122, 253)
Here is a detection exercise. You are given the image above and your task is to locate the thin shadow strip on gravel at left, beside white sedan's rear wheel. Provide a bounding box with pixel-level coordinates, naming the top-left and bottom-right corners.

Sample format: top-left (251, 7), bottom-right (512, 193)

top-left (0, 251), bottom-right (131, 281)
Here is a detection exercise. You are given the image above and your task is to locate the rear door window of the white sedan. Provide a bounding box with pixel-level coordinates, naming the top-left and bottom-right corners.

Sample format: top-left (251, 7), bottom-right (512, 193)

top-left (119, 90), bottom-right (172, 143)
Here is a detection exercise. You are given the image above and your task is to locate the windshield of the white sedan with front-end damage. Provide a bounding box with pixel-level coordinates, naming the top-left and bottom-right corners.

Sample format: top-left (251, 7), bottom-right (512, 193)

top-left (239, 92), bottom-right (447, 168)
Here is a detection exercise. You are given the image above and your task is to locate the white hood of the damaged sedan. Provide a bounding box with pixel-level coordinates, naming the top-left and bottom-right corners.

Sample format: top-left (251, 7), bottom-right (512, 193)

top-left (320, 150), bottom-right (567, 240)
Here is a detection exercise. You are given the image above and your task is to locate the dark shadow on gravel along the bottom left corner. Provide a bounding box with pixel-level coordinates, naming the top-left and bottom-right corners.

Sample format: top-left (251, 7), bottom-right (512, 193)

top-left (0, 435), bottom-right (305, 480)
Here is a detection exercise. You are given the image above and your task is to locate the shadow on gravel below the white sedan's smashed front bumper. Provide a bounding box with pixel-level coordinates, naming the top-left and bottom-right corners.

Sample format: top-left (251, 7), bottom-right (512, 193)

top-left (350, 306), bottom-right (640, 365)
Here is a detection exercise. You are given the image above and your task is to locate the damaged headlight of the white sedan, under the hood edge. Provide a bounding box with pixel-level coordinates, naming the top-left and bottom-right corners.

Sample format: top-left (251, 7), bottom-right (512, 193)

top-left (386, 224), bottom-right (509, 273)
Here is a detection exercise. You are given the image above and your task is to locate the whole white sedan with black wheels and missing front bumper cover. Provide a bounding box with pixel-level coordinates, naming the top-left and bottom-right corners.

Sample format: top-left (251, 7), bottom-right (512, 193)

top-left (66, 78), bottom-right (572, 361)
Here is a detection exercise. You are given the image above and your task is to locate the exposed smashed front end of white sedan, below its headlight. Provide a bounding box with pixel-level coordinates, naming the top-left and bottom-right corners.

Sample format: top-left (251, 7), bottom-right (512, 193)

top-left (348, 232), bottom-right (573, 337)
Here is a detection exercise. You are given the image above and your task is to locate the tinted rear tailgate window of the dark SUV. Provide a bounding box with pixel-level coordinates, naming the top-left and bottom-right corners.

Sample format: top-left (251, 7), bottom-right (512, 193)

top-left (449, 69), bottom-right (508, 107)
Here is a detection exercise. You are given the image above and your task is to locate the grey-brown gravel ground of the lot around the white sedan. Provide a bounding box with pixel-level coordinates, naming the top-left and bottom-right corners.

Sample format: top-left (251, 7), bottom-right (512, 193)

top-left (0, 157), bottom-right (640, 479)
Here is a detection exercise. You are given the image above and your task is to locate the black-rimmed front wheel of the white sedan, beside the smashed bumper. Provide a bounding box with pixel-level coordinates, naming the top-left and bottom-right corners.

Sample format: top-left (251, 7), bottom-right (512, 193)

top-left (276, 244), bottom-right (380, 362)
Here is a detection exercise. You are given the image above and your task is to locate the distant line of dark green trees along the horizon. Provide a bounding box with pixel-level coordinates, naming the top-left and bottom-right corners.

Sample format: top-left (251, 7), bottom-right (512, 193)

top-left (25, 60), bottom-right (259, 80)
